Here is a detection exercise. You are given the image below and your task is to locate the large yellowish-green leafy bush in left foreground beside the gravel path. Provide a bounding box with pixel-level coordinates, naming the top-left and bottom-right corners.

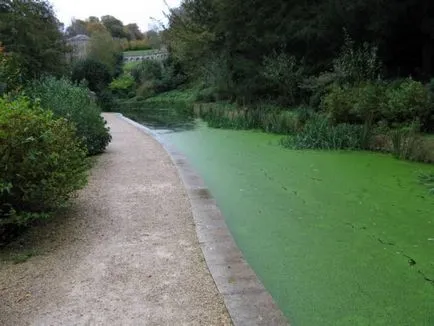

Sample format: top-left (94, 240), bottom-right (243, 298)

top-left (0, 98), bottom-right (88, 234)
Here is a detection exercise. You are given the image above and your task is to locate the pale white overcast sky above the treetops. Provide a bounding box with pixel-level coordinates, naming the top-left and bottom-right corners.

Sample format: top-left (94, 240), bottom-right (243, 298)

top-left (49, 0), bottom-right (181, 31)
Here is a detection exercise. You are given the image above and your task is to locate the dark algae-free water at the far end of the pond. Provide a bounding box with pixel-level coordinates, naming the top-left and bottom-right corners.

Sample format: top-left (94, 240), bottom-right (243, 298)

top-left (119, 108), bottom-right (195, 134)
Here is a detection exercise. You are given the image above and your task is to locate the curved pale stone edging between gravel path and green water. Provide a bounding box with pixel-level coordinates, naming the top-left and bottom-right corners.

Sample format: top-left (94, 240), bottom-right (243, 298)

top-left (119, 114), bottom-right (288, 326)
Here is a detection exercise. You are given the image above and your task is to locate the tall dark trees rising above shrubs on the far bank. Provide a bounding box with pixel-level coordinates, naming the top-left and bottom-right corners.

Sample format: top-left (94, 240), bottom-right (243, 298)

top-left (165, 0), bottom-right (434, 100)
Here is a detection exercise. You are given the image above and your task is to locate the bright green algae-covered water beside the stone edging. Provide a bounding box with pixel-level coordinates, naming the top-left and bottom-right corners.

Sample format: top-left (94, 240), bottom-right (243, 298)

top-left (123, 108), bottom-right (434, 326)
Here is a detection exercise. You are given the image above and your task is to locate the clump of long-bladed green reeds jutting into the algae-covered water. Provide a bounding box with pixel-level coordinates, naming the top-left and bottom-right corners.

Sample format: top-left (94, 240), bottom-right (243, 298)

top-left (282, 115), bottom-right (368, 149)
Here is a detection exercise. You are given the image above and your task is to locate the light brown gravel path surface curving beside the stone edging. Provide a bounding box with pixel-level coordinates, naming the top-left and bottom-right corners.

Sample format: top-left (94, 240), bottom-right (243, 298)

top-left (0, 114), bottom-right (230, 325)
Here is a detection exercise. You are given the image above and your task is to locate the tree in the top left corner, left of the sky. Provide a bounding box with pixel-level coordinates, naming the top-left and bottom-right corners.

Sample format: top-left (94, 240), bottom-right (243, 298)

top-left (0, 0), bottom-right (66, 80)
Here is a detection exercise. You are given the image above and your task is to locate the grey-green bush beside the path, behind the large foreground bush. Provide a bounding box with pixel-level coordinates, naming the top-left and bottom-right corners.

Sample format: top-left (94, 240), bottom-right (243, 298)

top-left (27, 77), bottom-right (111, 155)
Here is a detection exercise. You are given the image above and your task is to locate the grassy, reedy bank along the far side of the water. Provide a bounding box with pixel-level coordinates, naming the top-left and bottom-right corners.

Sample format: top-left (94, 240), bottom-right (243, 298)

top-left (123, 89), bottom-right (434, 163)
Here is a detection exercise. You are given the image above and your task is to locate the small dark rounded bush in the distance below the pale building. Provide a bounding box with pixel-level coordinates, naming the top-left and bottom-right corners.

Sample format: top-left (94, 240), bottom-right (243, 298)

top-left (71, 59), bottom-right (112, 94)
